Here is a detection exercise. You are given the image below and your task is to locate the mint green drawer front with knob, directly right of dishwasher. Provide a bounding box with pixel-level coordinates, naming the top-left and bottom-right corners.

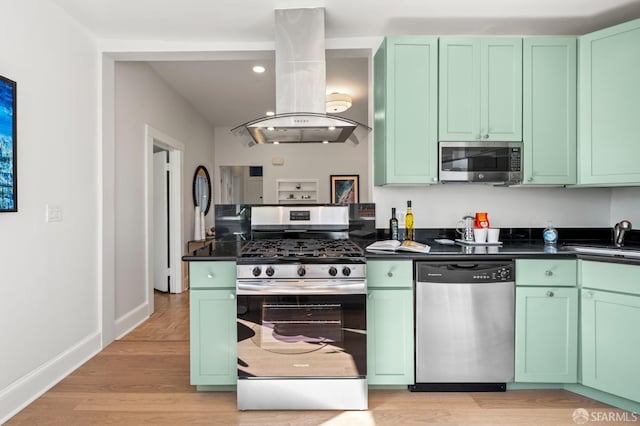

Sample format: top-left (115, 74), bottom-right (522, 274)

top-left (516, 259), bottom-right (577, 287)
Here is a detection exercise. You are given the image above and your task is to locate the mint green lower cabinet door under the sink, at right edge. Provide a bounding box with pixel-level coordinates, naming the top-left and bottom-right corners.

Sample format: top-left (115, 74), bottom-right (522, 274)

top-left (581, 289), bottom-right (640, 402)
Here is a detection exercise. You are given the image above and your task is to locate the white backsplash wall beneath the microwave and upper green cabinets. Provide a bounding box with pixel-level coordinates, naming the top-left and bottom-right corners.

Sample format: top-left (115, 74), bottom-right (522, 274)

top-left (373, 184), bottom-right (612, 228)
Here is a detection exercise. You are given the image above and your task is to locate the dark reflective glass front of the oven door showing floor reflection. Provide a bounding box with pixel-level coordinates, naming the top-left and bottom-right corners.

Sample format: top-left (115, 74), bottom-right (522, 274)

top-left (238, 295), bottom-right (366, 378)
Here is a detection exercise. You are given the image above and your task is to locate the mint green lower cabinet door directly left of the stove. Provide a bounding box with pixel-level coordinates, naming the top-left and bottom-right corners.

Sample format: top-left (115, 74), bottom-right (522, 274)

top-left (189, 288), bottom-right (237, 385)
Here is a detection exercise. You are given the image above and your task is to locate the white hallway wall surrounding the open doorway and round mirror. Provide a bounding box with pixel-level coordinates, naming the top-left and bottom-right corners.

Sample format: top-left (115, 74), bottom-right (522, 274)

top-left (115, 62), bottom-right (214, 320)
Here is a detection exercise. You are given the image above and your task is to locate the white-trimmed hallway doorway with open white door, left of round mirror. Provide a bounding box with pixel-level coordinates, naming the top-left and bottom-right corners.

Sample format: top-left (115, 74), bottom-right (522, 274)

top-left (145, 125), bottom-right (184, 315)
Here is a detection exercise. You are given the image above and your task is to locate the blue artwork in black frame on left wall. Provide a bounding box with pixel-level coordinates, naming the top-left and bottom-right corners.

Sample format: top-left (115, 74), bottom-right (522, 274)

top-left (0, 75), bottom-right (18, 213)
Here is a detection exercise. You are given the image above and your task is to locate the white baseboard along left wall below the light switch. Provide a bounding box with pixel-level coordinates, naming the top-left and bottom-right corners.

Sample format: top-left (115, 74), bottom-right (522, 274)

top-left (0, 332), bottom-right (102, 424)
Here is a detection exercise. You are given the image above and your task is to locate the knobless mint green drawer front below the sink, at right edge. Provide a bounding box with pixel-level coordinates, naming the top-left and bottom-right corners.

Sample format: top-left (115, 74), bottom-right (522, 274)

top-left (579, 260), bottom-right (640, 295)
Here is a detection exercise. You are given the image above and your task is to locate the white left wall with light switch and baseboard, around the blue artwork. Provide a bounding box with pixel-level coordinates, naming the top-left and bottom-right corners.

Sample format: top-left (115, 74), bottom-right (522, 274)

top-left (0, 0), bottom-right (100, 423)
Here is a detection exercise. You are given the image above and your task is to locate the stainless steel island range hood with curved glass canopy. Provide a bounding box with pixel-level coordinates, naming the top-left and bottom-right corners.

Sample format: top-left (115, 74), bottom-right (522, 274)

top-left (231, 8), bottom-right (370, 145)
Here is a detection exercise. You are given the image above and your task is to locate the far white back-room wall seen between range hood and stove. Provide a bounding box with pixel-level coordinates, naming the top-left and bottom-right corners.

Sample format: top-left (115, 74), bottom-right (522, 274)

top-left (213, 127), bottom-right (370, 204)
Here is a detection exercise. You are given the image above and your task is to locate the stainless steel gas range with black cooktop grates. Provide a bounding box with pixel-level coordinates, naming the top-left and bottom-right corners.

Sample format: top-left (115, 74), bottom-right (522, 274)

top-left (237, 206), bottom-right (368, 410)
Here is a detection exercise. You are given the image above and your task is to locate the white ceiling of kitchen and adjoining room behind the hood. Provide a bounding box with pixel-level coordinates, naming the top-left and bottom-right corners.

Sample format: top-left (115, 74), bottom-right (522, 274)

top-left (52, 0), bottom-right (640, 126)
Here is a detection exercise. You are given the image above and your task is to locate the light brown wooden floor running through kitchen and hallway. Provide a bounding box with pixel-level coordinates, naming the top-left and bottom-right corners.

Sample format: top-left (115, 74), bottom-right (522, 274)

top-left (7, 292), bottom-right (628, 426)
